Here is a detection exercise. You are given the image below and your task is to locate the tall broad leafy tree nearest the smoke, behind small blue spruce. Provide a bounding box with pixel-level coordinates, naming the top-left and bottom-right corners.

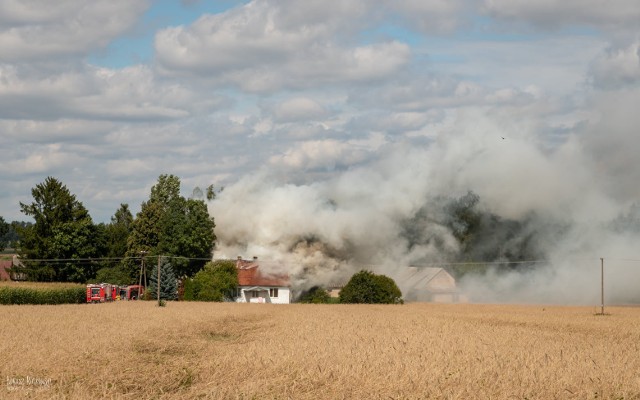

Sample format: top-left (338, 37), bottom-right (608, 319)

top-left (127, 175), bottom-right (216, 277)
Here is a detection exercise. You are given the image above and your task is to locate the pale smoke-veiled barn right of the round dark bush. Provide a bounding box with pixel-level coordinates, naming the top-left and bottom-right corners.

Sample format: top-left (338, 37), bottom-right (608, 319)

top-left (392, 267), bottom-right (467, 303)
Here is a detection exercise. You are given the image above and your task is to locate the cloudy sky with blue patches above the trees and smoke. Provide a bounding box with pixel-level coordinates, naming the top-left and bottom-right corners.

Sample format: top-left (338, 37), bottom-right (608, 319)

top-left (0, 0), bottom-right (640, 227)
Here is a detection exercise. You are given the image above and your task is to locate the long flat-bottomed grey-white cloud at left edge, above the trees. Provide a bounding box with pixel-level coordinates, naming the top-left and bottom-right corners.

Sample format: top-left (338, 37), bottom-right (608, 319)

top-left (0, 65), bottom-right (210, 120)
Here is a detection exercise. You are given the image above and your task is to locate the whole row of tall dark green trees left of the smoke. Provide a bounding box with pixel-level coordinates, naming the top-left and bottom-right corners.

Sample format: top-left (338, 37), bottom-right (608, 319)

top-left (0, 175), bottom-right (216, 284)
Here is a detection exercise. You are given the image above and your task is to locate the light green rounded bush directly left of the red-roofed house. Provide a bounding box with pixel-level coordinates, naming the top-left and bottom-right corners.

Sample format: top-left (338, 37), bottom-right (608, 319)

top-left (190, 260), bottom-right (238, 301)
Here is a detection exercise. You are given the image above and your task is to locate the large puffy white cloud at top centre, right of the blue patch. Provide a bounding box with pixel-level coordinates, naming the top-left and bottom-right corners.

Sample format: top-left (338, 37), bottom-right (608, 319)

top-left (155, 1), bottom-right (410, 91)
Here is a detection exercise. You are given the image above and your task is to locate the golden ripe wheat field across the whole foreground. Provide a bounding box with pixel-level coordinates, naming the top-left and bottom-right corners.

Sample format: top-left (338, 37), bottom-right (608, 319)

top-left (0, 302), bottom-right (640, 399)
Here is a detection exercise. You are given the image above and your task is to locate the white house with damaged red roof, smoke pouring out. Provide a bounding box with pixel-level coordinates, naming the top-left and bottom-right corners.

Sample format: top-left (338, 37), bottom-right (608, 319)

top-left (234, 257), bottom-right (291, 304)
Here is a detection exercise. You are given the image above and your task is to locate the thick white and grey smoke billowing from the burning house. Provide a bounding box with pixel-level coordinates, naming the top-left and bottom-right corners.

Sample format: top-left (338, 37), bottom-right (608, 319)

top-left (211, 111), bottom-right (640, 304)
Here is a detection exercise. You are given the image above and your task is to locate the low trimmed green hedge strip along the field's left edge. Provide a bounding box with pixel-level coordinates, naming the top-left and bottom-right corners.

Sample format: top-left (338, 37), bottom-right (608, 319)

top-left (0, 287), bottom-right (87, 304)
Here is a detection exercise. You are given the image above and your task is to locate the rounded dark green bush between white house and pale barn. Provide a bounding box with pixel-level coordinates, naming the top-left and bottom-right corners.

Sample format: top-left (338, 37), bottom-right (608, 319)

top-left (340, 271), bottom-right (403, 304)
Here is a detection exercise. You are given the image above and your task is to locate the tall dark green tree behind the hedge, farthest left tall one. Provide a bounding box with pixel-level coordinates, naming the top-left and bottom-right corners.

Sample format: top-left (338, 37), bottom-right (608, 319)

top-left (18, 177), bottom-right (99, 282)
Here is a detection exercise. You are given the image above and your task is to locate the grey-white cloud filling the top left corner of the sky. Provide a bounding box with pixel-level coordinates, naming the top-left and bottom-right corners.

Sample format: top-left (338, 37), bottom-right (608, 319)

top-left (0, 0), bottom-right (149, 62)
